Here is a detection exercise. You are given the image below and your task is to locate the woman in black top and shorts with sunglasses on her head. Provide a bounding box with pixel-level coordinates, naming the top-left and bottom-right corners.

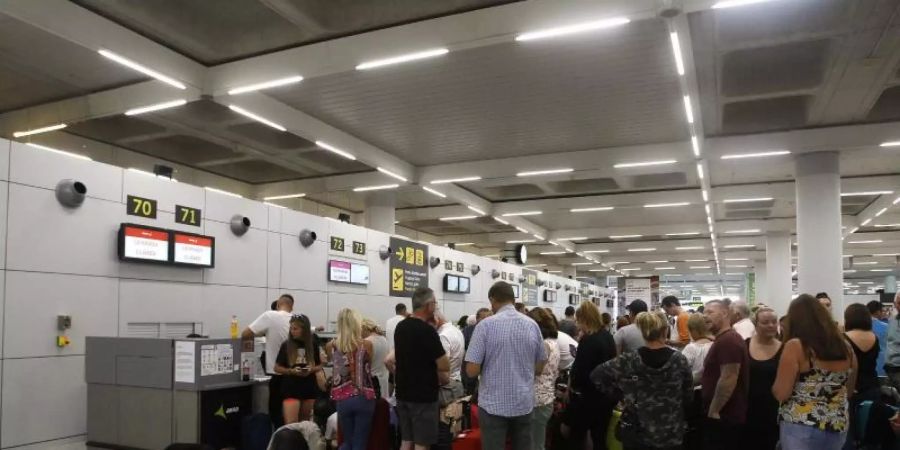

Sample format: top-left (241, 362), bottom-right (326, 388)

top-left (275, 314), bottom-right (322, 424)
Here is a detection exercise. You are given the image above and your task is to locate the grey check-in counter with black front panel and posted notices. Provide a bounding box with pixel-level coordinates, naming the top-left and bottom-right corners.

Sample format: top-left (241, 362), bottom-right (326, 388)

top-left (85, 337), bottom-right (264, 450)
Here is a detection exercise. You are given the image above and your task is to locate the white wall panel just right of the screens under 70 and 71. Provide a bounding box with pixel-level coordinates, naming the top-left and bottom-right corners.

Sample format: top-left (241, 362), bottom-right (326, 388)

top-left (203, 221), bottom-right (269, 287)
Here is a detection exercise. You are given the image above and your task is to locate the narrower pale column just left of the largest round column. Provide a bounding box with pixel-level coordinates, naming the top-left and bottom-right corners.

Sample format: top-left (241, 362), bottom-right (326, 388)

top-left (758, 231), bottom-right (791, 316)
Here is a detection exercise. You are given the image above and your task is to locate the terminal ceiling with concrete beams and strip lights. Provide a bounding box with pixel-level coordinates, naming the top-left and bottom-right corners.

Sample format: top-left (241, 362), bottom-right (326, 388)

top-left (0, 0), bottom-right (900, 294)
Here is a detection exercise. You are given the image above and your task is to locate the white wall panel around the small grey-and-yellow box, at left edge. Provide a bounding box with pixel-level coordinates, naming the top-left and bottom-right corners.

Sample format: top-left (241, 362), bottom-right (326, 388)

top-left (3, 271), bottom-right (119, 358)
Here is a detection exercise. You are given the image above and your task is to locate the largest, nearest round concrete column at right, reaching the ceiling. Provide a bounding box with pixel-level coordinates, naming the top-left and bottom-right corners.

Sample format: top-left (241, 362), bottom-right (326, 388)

top-left (795, 152), bottom-right (844, 316)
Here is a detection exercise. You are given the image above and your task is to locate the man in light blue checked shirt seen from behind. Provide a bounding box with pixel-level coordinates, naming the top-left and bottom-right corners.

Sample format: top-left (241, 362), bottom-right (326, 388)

top-left (466, 281), bottom-right (547, 450)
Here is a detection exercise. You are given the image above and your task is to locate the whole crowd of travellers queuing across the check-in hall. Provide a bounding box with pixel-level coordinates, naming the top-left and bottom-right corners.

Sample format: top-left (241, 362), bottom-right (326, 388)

top-left (244, 288), bottom-right (900, 450)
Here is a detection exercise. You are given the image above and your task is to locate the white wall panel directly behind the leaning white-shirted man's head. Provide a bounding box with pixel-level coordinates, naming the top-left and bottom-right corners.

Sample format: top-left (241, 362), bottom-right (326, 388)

top-left (200, 285), bottom-right (272, 338)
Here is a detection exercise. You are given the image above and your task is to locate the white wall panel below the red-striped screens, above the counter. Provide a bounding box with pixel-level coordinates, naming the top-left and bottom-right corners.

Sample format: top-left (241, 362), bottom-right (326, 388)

top-left (119, 280), bottom-right (203, 336)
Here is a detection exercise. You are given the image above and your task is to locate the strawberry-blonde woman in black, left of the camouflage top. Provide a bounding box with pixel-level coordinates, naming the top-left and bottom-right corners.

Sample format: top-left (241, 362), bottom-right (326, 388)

top-left (564, 301), bottom-right (616, 450)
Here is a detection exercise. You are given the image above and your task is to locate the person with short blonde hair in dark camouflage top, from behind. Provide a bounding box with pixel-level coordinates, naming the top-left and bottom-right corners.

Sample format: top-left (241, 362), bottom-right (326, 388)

top-left (591, 312), bottom-right (693, 450)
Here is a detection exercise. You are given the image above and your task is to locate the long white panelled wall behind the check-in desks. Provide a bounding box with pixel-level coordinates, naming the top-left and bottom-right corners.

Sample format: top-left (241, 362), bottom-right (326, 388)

top-left (0, 139), bottom-right (604, 449)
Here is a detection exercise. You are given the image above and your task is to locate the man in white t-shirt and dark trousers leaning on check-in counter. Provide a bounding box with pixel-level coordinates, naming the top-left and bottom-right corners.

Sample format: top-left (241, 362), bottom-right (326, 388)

top-left (241, 294), bottom-right (294, 428)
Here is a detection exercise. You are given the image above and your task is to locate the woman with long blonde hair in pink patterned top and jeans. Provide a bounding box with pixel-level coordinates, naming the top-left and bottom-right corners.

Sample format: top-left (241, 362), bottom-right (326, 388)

top-left (326, 308), bottom-right (375, 450)
